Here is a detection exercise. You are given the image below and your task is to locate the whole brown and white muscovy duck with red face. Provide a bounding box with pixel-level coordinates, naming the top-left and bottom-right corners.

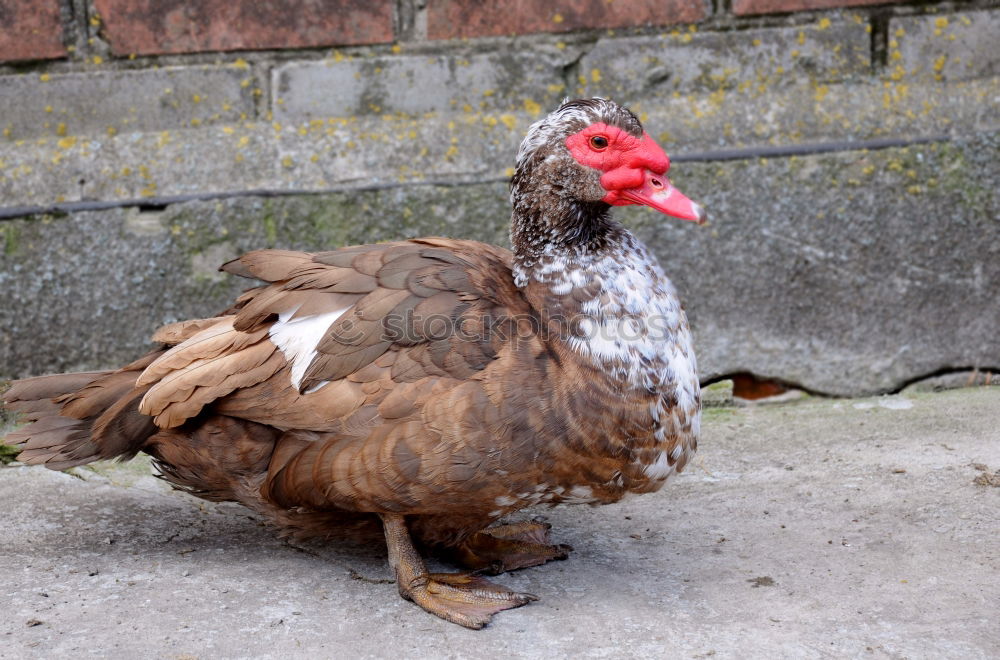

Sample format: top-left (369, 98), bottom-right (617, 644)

top-left (5, 98), bottom-right (705, 628)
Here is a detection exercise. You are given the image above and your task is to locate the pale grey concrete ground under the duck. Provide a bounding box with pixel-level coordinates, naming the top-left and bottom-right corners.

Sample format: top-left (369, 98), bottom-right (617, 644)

top-left (0, 388), bottom-right (1000, 658)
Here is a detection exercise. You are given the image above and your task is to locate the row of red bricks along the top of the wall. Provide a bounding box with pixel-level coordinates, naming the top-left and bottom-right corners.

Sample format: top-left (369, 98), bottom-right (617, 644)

top-left (0, 0), bottom-right (993, 65)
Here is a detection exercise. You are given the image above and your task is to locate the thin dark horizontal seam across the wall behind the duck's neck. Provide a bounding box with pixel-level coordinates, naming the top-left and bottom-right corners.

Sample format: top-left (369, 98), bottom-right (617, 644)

top-left (0, 134), bottom-right (952, 221)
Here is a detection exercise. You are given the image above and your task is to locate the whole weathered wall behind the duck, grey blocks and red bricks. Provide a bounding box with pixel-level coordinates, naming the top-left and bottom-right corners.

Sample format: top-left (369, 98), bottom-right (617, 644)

top-left (0, 0), bottom-right (1000, 394)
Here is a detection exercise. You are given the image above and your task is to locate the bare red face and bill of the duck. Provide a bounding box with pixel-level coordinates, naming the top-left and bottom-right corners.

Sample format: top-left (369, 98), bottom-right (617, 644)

top-left (566, 122), bottom-right (706, 224)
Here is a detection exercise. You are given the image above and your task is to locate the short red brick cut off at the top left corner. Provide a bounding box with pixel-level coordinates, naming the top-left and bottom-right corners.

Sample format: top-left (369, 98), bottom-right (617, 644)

top-left (0, 0), bottom-right (66, 62)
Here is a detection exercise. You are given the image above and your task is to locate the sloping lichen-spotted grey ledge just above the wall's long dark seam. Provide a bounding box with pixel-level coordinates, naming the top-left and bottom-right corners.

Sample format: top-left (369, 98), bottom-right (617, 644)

top-left (0, 73), bottom-right (1000, 206)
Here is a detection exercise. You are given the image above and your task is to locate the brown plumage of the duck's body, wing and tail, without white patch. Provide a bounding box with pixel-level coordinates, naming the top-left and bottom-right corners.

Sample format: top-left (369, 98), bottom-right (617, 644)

top-left (1, 239), bottom-right (688, 544)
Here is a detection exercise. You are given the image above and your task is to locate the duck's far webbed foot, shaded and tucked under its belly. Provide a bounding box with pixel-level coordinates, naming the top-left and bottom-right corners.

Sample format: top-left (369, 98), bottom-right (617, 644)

top-left (455, 520), bottom-right (573, 575)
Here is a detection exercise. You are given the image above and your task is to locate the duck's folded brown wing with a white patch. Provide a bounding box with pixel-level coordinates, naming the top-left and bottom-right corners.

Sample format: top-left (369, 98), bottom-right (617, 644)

top-left (137, 239), bottom-right (526, 430)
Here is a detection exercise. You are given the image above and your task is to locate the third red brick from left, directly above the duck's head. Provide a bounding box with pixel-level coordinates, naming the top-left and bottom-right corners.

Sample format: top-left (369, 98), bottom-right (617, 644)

top-left (427, 0), bottom-right (705, 39)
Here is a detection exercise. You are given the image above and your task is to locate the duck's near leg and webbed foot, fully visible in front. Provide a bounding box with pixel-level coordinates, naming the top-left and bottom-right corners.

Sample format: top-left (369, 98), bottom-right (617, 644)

top-left (381, 514), bottom-right (538, 630)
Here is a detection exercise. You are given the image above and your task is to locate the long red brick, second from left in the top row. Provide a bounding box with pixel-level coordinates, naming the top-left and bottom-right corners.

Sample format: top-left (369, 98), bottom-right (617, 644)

top-left (94, 0), bottom-right (393, 55)
